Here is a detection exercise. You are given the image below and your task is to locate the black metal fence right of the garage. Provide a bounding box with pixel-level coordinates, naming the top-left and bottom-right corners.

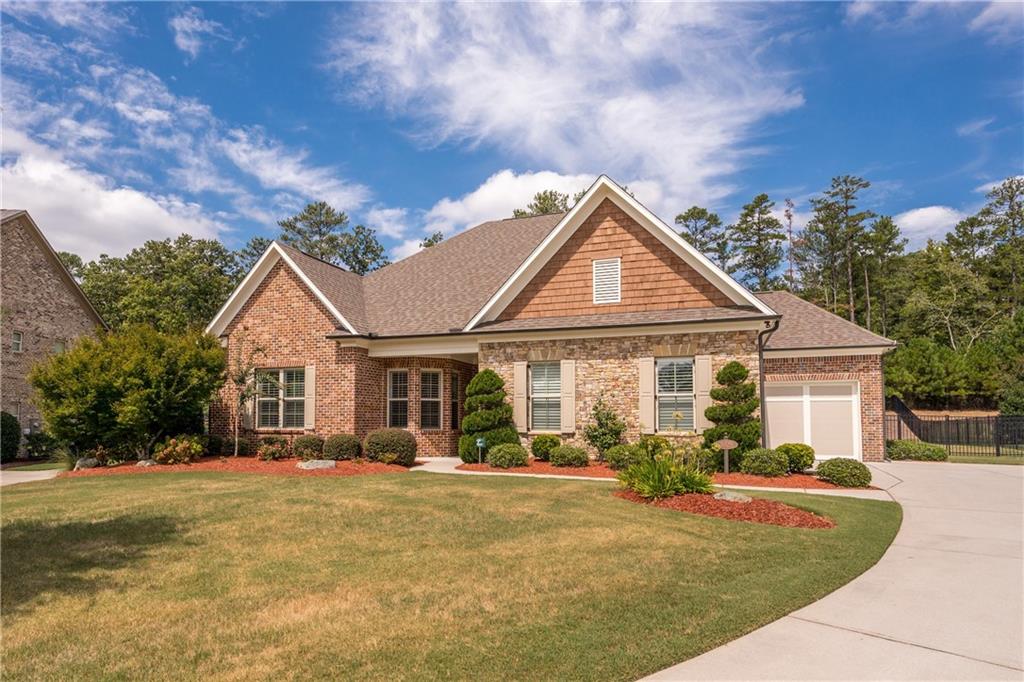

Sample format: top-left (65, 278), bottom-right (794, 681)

top-left (885, 401), bottom-right (1024, 458)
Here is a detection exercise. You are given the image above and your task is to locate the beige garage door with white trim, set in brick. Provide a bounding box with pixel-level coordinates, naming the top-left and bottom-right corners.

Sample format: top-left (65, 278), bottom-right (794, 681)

top-left (765, 382), bottom-right (860, 460)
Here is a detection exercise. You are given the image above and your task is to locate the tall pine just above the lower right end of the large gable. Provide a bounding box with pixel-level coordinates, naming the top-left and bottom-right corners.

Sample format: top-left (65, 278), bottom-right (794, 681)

top-left (729, 194), bottom-right (785, 291)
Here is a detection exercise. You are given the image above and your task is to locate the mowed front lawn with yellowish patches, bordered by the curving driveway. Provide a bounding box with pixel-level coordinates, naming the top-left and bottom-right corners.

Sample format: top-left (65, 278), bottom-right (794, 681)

top-left (0, 472), bottom-right (901, 680)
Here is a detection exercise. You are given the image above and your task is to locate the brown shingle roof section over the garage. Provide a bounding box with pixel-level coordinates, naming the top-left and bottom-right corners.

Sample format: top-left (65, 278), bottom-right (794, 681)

top-left (755, 291), bottom-right (896, 350)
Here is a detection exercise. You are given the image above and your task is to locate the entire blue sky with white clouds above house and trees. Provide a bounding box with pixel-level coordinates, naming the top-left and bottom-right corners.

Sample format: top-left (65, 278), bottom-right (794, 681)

top-left (0, 2), bottom-right (1024, 258)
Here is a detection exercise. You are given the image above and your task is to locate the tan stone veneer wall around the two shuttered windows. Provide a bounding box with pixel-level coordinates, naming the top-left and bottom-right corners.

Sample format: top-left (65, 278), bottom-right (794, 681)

top-left (479, 331), bottom-right (758, 454)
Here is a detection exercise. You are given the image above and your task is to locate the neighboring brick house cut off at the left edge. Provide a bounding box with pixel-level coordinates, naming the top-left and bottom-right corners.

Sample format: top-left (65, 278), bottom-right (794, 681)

top-left (0, 209), bottom-right (104, 431)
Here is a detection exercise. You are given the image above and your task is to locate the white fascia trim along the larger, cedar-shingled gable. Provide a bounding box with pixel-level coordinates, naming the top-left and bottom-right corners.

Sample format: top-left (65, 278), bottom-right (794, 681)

top-left (463, 175), bottom-right (776, 332)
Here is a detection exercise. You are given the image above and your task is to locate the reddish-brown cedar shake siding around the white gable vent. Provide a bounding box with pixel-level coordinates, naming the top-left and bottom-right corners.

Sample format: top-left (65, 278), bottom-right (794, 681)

top-left (498, 199), bottom-right (734, 321)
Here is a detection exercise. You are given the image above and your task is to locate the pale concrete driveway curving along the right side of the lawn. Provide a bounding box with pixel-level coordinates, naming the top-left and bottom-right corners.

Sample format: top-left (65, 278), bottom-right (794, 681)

top-left (647, 462), bottom-right (1024, 680)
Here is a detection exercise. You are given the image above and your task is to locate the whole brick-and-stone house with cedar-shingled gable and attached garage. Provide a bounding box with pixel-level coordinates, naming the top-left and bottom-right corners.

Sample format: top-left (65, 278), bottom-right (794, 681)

top-left (207, 176), bottom-right (894, 460)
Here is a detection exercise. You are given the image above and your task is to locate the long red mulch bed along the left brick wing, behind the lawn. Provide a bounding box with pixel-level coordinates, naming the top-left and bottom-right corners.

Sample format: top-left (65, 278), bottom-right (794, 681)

top-left (60, 457), bottom-right (409, 478)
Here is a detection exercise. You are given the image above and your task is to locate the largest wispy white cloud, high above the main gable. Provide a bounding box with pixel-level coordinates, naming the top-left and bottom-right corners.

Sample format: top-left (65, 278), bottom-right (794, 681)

top-left (330, 3), bottom-right (803, 205)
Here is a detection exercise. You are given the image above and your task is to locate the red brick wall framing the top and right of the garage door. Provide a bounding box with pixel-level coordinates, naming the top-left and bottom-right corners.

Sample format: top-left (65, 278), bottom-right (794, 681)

top-left (765, 355), bottom-right (885, 462)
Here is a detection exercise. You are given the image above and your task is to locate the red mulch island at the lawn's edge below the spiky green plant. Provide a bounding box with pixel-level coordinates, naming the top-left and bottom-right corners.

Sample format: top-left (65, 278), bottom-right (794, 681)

top-left (614, 491), bottom-right (836, 528)
